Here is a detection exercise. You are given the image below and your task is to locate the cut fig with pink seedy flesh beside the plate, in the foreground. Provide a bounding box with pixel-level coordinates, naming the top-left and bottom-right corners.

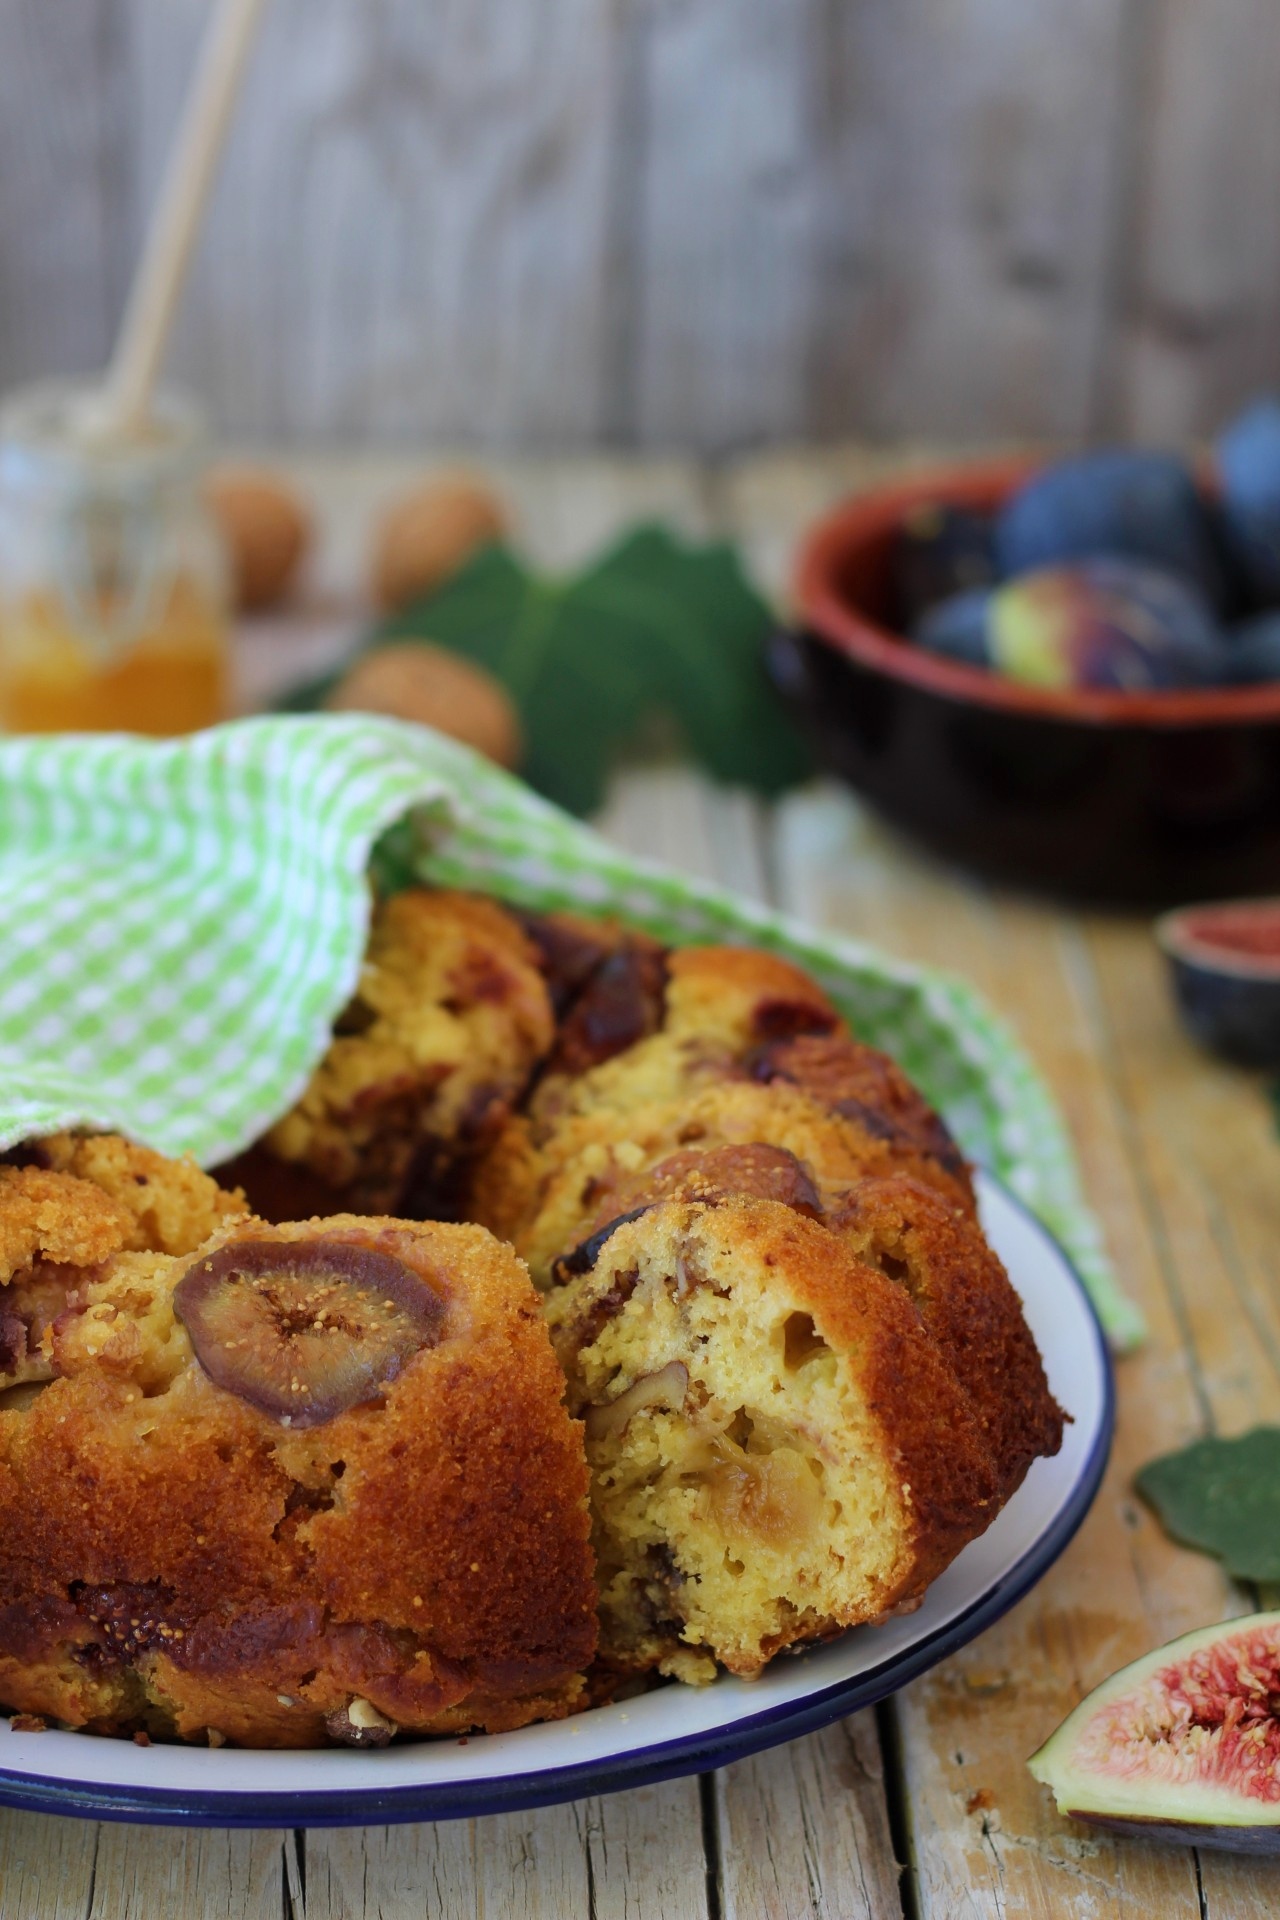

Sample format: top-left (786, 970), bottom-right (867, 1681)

top-left (1029, 1613), bottom-right (1280, 1853)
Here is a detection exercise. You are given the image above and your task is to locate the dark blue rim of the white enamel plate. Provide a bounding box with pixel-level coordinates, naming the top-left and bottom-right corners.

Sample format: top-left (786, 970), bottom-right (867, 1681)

top-left (0, 1167), bottom-right (1115, 1828)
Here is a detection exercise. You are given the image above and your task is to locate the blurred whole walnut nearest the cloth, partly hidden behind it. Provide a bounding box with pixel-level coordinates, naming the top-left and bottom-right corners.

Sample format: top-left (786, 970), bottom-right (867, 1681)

top-left (324, 639), bottom-right (524, 768)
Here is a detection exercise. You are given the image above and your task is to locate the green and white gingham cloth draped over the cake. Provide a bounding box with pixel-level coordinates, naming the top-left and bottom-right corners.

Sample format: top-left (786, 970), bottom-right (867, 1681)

top-left (0, 716), bottom-right (1142, 1346)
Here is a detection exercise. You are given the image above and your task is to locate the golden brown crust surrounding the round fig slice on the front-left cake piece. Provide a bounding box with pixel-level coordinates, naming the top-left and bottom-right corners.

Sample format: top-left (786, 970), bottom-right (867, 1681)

top-left (0, 1175), bottom-right (597, 1745)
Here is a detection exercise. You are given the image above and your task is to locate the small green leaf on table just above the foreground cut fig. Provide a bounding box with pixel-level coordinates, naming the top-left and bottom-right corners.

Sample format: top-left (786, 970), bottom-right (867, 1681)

top-left (1134, 1427), bottom-right (1280, 1584)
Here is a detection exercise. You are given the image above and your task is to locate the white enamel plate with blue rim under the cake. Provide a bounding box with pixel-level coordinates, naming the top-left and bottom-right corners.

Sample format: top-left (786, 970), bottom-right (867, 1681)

top-left (0, 1175), bottom-right (1113, 1826)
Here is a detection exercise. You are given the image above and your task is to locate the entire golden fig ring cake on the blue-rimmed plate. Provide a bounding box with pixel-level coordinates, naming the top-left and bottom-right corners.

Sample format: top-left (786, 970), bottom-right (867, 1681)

top-left (0, 887), bottom-right (1063, 1745)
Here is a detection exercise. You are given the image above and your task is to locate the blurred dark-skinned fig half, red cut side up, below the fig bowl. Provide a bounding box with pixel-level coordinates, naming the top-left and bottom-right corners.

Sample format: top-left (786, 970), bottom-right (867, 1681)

top-left (1155, 900), bottom-right (1280, 1068)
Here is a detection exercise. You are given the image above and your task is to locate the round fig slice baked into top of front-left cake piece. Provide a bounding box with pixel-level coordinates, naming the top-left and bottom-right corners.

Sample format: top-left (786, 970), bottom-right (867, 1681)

top-left (173, 1238), bottom-right (445, 1427)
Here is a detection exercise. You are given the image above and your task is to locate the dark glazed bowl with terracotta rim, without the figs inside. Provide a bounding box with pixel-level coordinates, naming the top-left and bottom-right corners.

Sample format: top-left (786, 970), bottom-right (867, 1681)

top-left (771, 461), bottom-right (1280, 904)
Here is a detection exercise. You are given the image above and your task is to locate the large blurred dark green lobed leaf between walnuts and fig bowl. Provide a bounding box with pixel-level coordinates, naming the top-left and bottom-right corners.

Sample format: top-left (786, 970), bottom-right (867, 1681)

top-left (282, 526), bottom-right (810, 814)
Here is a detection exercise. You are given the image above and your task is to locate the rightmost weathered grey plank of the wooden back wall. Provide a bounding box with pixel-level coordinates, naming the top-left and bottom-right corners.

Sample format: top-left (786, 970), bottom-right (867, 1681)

top-left (1098, 0), bottom-right (1280, 442)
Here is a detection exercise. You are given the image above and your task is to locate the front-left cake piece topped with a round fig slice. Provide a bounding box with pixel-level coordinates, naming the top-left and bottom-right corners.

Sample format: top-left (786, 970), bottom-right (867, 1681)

top-left (0, 1139), bottom-right (597, 1747)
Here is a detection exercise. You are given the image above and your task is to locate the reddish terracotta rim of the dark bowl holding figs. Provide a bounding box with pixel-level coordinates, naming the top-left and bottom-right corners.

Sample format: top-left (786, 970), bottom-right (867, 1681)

top-left (793, 455), bottom-right (1280, 728)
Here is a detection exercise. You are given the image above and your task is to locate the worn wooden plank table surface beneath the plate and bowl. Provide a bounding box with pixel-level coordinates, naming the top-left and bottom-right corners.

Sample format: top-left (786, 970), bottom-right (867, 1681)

top-left (0, 449), bottom-right (1280, 1920)
